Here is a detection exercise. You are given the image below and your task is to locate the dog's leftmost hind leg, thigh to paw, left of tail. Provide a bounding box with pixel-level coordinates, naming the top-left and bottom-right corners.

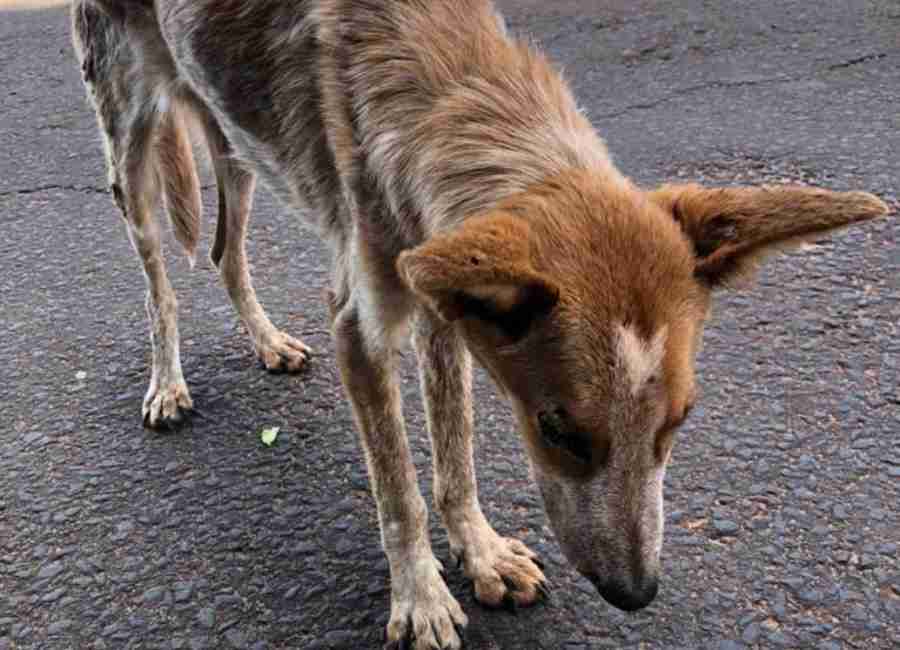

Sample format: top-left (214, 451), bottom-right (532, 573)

top-left (72, 2), bottom-right (193, 427)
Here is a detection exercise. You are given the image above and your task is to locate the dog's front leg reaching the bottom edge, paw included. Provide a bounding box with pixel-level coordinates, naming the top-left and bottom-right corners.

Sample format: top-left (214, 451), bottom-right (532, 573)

top-left (334, 303), bottom-right (467, 650)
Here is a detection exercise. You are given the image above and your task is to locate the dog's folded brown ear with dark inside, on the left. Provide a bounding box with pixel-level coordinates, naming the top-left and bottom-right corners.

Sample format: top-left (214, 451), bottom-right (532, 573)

top-left (397, 213), bottom-right (559, 340)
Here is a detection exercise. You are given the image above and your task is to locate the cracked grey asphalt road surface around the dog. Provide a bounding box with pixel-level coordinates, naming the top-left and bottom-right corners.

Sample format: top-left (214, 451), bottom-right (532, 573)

top-left (0, 0), bottom-right (900, 650)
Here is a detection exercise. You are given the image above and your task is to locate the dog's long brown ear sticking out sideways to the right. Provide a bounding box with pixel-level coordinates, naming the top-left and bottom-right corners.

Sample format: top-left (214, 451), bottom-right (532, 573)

top-left (650, 184), bottom-right (888, 287)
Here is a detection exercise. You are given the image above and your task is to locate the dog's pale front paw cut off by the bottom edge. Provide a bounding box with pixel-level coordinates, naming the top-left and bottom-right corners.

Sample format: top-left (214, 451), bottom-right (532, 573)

top-left (384, 559), bottom-right (469, 650)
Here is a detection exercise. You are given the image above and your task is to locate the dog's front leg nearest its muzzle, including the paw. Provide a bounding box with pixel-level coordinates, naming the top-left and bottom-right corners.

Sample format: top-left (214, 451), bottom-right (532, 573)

top-left (414, 312), bottom-right (547, 607)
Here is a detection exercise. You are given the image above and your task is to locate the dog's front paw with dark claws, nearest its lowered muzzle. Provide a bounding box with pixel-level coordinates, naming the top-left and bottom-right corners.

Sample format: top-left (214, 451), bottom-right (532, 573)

top-left (451, 518), bottom-right (550, 612)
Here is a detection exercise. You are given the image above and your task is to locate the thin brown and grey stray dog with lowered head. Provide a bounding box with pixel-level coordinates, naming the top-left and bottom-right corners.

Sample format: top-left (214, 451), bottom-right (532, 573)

top-left (72, 0), bottom-right (887, 650)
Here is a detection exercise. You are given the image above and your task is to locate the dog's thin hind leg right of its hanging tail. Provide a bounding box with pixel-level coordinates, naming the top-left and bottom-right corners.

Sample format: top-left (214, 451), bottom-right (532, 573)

top-left (203, 114), bottom-right (312, 372)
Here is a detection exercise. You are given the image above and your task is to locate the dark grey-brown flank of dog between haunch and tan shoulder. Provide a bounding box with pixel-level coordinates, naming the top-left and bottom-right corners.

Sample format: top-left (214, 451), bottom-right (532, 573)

top-left (158, 0), bottom-right (340, 229)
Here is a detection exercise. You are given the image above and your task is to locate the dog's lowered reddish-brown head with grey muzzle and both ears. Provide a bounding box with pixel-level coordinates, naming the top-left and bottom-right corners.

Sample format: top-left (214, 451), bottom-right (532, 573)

top-left (398, 175), bottom-right (887, 610)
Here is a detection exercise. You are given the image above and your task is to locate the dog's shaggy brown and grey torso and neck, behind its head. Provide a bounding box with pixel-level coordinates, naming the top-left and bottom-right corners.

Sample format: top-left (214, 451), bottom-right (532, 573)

top-left (77, 0), bottom-right (620, 253)
